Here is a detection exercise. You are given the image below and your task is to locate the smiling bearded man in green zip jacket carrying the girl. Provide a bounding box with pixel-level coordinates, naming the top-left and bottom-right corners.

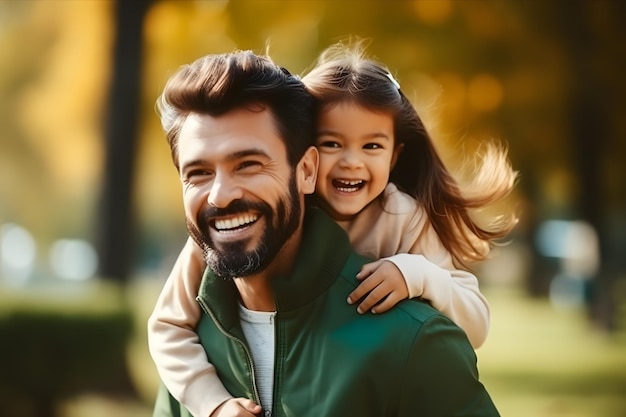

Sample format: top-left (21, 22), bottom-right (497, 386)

top-left (154, 52), bottom-right (498, 417)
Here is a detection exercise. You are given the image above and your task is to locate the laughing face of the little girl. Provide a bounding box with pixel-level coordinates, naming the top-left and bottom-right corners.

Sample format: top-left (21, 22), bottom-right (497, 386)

top-left (316, 102), bottom-right (400, 220)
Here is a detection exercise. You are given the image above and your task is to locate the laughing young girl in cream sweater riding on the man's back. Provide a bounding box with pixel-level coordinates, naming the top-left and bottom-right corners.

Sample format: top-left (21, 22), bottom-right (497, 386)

top-left (148, 44), bottom-right (516, 417)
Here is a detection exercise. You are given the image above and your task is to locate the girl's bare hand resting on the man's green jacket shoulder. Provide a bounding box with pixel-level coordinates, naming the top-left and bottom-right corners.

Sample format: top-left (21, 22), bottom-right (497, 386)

top-left (348, 259), bottom-right (409, 314)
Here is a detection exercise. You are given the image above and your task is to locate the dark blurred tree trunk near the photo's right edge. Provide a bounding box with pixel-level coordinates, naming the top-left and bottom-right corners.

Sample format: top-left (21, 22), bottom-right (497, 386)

top-left (560, 0), bottom-right (623, 330)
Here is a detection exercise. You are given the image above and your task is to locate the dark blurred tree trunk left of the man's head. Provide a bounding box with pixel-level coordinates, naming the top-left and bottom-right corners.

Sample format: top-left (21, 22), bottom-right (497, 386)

top-left (96, 0), bottom-right (152, 282)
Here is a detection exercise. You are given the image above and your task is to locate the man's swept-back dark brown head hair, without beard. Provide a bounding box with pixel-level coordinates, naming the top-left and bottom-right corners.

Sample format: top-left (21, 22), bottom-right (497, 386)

top-left (156, 51), bottom-right (315, 168)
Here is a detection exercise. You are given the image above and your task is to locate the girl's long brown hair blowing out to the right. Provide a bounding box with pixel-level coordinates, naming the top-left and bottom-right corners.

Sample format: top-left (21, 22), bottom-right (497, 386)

top-left (302, 41), bottom-right (517, 267)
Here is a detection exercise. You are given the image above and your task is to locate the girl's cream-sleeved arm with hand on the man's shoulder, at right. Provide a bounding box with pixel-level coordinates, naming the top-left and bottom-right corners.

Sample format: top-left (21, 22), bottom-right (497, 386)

top-left (347, 183), bottom-right (490, 348)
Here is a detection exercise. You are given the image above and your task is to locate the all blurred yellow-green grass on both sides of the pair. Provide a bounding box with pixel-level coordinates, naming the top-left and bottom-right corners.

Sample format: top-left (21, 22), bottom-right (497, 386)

top-left (0, 279), bottom-right (626, 417)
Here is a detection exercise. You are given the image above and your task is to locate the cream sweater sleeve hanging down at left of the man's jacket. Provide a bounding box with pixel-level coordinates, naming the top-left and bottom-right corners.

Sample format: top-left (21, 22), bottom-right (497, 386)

top-left (148, 239), bottom-right (232, 417)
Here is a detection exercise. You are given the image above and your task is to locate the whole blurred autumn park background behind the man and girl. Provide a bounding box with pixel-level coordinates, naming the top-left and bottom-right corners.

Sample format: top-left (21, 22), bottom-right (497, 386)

top-left (0, 0), bottom-right (626, 417)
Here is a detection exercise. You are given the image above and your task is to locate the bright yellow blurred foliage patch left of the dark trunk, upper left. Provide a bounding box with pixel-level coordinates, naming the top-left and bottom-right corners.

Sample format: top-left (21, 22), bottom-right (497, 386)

top-left (18, 2), bottom-right (111, 193)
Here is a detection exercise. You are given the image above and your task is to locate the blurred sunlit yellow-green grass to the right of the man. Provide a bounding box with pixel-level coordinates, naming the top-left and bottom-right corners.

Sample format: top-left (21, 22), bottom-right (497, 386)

top-left (477, 289), bottom-right (626, 417)
